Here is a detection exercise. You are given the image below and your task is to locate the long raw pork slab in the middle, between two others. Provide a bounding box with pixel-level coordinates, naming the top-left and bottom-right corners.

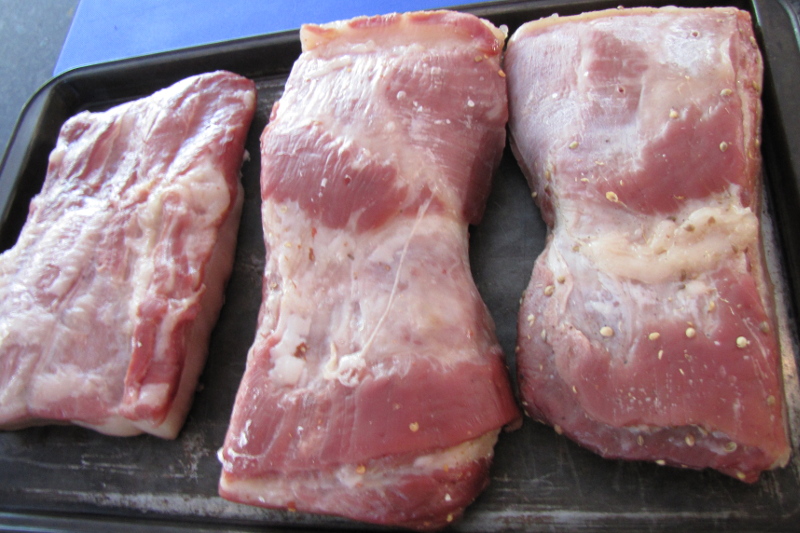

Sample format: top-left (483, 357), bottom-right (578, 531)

top-left (220, 12), bottom-right (519, 529)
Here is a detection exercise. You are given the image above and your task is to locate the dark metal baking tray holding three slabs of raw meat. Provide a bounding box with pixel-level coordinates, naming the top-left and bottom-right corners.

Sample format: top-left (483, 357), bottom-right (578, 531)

top-left (0, 0), bottom-right (800, 532)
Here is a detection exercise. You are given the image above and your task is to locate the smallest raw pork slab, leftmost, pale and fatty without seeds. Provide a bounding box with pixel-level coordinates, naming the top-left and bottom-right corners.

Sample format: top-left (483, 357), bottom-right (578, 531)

top-left (0, 72), bottom-right (255, 438)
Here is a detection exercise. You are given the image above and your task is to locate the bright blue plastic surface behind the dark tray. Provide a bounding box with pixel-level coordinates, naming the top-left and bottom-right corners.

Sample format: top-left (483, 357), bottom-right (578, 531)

top-left (53, 0), bottom-right (465, 75)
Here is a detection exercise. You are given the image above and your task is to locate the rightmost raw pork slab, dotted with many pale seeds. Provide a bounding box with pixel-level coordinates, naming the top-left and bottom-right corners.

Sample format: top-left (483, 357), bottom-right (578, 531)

top-left (505, 8), bottom-right (790, 482)
